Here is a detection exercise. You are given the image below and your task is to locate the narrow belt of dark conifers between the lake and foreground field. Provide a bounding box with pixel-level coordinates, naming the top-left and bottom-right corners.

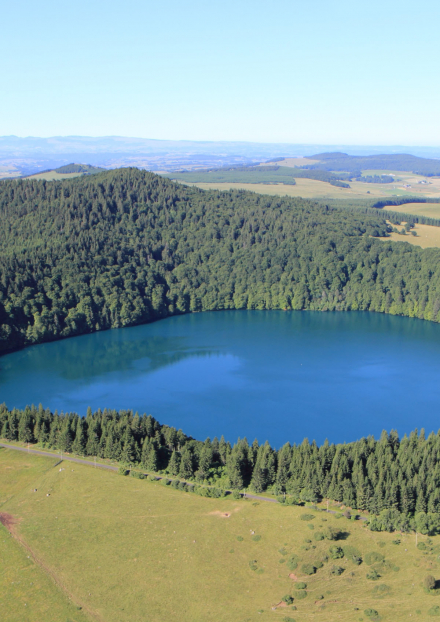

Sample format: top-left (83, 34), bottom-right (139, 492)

top-left (0, 405), bottom-right (440, 529)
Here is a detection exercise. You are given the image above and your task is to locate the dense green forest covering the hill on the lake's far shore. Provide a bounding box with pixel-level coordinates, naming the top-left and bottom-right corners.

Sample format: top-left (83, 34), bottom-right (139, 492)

top-left (0, 169), bottom-right (440, 352)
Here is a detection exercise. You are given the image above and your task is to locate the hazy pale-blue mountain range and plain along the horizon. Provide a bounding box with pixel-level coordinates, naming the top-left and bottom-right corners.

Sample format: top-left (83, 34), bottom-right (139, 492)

top-left (0, 136), bottom-right (440, 177)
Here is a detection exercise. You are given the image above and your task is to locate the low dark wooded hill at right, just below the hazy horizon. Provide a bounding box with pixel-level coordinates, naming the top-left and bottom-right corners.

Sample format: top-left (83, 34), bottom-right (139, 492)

top-left (304, 152), bottom-right (440, 177)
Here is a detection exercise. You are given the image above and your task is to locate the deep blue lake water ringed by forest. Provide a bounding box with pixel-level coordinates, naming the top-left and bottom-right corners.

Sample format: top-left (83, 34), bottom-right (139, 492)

top-left (0, 311), bottom-right (440, 447)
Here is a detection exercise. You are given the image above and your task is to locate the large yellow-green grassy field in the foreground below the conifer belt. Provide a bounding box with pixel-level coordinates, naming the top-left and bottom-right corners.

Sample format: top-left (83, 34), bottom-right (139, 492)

top-left (0, 450), bottom-right (440, 622)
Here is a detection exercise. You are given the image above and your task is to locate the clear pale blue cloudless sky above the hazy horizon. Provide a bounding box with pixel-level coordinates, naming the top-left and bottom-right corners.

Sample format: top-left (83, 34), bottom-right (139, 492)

top-left (0, 0), bottom-right (440, 146)
